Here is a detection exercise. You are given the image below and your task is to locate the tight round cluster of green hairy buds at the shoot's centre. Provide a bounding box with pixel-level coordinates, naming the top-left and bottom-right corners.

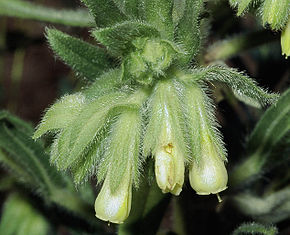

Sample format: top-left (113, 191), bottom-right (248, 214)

top-left (123, 38), bottom-right (179, 85)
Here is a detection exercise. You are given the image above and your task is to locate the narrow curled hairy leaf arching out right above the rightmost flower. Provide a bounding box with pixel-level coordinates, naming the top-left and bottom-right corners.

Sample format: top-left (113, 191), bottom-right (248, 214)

top-left (192, 66), bottom-right (279, 107)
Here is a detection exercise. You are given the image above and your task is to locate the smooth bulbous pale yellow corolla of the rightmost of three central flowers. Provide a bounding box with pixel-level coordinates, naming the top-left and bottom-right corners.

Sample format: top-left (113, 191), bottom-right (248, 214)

top-left (189, 134), bottom-right (228, 195)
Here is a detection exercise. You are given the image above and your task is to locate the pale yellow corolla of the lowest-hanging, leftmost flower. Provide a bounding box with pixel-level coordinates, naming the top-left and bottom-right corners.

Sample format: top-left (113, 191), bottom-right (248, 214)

top-left (95, 171), bottom-right (132, 224)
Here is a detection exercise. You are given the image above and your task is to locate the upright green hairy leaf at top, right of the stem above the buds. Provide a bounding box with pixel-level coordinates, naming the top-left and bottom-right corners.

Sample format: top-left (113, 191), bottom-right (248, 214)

top-left (175, 0), bottom-right (203, 64)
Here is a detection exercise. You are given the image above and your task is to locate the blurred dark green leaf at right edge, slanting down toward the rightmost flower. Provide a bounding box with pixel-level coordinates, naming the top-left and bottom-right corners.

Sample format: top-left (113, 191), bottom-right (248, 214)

top-left (230, 89), bottom-right (290, 186)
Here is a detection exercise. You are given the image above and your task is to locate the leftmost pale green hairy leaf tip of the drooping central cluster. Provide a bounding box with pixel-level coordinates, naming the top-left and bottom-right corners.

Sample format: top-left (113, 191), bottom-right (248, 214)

top-left (33, 93), bottom-right (85, 139)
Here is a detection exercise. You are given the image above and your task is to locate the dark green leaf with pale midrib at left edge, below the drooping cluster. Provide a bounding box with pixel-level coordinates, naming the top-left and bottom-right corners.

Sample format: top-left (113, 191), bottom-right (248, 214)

top-left (0, 114), bottom-right (62, 197)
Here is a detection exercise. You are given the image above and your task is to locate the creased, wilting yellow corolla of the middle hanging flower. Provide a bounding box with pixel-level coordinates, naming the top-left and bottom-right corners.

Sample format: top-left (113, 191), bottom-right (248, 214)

top-left (155, 144), bottom-right (184, 195)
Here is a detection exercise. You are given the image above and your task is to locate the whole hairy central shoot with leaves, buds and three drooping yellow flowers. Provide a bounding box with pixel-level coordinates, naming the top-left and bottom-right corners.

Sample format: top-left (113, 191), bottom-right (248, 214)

top-left (34, 0), bottom-right (278, 223)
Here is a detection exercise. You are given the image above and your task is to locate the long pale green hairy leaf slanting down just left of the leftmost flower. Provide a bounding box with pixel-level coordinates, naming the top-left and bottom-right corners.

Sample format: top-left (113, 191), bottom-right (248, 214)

top-left (57, 92), bottom-right (125, 169)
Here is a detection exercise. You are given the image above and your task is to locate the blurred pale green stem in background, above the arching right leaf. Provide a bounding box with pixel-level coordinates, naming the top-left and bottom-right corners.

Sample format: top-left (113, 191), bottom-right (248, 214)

top-left (204, 30), bottom-right (278, 62)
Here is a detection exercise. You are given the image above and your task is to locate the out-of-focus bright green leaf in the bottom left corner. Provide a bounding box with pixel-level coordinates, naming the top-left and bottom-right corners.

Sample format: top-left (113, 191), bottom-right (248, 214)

top-left (0, 194), bottom-right (49, 235)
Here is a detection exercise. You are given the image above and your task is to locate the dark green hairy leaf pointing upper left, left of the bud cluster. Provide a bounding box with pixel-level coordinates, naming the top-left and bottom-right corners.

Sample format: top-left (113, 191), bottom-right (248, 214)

top-left (46, 28), bottom-right (112, 81)
